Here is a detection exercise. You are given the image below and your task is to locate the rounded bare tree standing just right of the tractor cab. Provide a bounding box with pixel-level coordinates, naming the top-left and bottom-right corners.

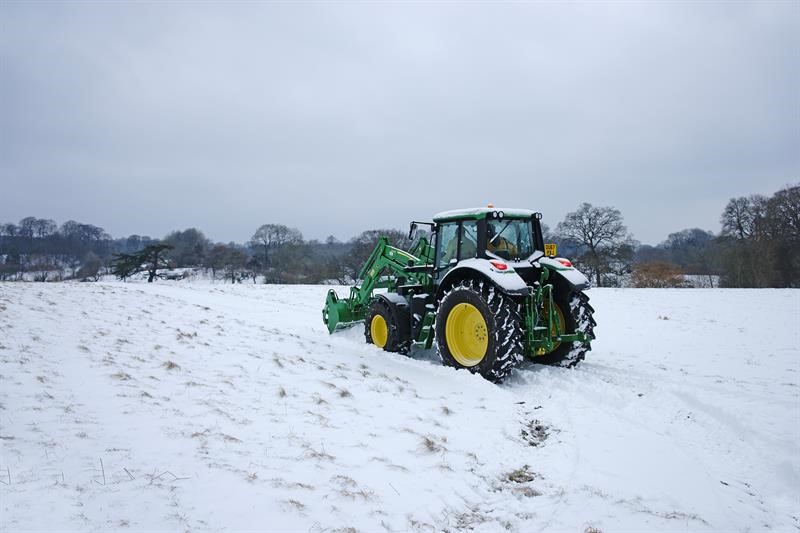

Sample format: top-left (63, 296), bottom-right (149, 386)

top-left (556, 202), bottom-right (636, 287)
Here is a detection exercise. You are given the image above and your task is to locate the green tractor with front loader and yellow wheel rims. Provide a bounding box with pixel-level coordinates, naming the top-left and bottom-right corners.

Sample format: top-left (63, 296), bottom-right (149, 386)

top-left (322, 206), bottom-right (595, 382)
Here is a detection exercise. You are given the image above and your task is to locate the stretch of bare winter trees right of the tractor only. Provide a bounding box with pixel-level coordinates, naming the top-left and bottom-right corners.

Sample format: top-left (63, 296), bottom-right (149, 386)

top-left (550, 185), bottom-right (800, 288)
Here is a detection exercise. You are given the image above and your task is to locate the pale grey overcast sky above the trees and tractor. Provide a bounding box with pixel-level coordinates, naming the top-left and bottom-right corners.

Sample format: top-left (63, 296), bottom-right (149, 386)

top-left (0, 0), bottom-right (800, 244)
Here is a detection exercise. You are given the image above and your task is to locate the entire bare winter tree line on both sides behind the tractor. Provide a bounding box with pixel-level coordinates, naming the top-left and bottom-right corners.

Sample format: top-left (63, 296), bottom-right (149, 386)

top-left (0, 185), bottom-right (800, 287)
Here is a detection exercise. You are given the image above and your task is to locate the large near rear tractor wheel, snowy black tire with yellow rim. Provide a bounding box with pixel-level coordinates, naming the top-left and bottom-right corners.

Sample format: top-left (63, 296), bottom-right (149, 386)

top-left (434, 280), bottom-right (525, 383)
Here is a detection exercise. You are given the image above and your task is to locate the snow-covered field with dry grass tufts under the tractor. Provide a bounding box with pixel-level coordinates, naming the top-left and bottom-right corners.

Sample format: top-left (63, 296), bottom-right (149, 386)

top-left (0, 282), bottom-right (800, 532)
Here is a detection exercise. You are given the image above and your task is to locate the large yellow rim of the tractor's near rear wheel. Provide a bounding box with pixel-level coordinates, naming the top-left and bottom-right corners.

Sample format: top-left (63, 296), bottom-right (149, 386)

top-left (444, 303), bottom-right (489, 366)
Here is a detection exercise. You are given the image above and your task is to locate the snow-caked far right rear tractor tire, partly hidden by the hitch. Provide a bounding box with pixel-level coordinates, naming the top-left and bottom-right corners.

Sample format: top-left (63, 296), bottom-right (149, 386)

top-left (533, 284), bottom-right (597, 368)
